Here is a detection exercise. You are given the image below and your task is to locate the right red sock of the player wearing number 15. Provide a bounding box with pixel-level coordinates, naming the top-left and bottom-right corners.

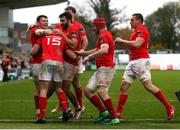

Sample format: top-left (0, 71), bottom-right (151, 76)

top-left (57, 91), bottom-right (68, 111)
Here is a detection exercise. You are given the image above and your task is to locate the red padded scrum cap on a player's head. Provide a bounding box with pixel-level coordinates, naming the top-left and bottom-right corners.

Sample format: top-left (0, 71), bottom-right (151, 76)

top-left (93, 17), bottom-right (106, 30)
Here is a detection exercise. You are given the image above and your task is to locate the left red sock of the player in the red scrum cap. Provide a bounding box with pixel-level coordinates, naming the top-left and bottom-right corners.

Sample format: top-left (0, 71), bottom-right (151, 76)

top-left (90, 95), bottom-right (106, 112)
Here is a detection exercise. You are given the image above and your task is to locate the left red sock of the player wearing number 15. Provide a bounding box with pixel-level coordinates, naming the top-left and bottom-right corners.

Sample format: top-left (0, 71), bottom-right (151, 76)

top-left (38, 97), bottom-right (47, 118)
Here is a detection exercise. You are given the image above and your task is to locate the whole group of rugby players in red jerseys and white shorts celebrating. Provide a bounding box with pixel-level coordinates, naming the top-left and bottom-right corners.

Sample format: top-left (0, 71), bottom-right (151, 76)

top-left (28, 6), bottom-right (175, 125)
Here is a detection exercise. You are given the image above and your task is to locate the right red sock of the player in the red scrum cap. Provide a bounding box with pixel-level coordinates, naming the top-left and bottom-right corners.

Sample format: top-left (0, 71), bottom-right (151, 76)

top-left (104, 98), bottom-right (116, 119)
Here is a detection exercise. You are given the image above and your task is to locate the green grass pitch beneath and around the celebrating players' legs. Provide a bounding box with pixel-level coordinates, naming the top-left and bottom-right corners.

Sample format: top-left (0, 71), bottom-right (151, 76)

top-left (0, 71), bottom-right (180, 129)
